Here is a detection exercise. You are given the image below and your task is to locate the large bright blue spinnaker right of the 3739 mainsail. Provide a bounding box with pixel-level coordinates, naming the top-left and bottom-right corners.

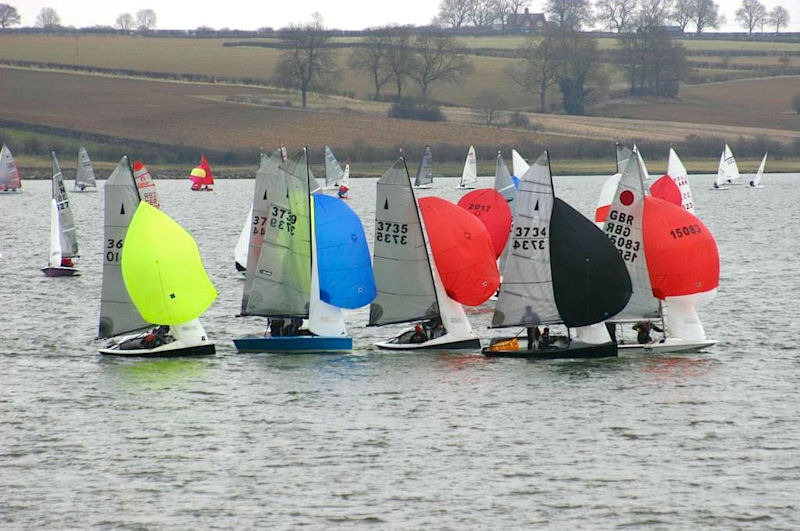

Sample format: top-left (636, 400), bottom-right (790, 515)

top-left (313, 194), bottom-right (378, 309)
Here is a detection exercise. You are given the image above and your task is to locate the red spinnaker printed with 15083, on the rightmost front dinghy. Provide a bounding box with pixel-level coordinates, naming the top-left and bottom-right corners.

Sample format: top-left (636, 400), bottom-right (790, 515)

top-left (642, 196), bottom-right (719, 300)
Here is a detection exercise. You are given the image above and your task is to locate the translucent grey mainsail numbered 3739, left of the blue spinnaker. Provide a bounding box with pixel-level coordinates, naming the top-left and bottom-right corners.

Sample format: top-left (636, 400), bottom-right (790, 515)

top-left (243, 148), bottom-right (313, 318)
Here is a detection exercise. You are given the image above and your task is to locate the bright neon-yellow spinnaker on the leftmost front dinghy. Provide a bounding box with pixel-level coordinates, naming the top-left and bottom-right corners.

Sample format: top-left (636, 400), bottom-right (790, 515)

top-left (121, 201), bottom-right (217, 325)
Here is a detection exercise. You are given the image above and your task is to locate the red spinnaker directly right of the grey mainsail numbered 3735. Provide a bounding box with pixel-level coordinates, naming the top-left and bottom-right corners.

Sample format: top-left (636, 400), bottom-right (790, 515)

top-left (419, 197), bottom-right (500, 306)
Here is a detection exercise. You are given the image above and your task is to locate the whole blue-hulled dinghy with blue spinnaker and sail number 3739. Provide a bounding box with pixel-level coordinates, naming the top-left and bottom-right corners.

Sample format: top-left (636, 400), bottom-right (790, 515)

top-left (234, 148), bottom-right (375, 353)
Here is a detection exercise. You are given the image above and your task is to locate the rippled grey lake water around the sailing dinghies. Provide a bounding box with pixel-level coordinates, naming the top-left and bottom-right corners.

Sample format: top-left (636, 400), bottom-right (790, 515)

top-left (0, 175), bottom-right (800, 529)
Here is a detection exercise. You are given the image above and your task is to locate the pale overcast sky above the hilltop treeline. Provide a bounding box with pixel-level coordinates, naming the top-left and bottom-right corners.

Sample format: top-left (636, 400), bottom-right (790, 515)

top-left (15, 0), bottom-right (800, 31)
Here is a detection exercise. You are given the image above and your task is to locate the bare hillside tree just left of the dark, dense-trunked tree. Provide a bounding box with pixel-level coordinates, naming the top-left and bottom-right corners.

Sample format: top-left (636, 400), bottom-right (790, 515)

top-left (506, 32), bottom-right (557, 112)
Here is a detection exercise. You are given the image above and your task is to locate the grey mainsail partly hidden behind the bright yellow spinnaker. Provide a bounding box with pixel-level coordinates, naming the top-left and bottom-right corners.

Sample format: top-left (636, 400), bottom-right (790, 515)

top-left (98, 156), bottom-right (150, 338)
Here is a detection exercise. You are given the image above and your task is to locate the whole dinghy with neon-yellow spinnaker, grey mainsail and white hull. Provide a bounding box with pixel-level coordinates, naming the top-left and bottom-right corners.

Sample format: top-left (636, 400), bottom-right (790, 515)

top-left (98, 157), bottom-right (217, 357)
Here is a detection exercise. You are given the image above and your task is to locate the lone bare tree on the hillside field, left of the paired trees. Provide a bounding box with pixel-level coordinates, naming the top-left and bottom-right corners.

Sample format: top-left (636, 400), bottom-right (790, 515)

top-left (275, 13), bottom-right (339, 108)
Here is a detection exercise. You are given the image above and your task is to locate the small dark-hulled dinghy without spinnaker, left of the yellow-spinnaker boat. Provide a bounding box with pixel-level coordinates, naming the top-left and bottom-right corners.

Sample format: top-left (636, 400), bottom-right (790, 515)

top-left (42, 153), bottom-right (79, 277)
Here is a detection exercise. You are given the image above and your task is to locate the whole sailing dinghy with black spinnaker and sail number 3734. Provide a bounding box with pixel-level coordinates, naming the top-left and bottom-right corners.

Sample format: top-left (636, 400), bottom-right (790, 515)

top-left (483, 152), bottom-right (631, 359)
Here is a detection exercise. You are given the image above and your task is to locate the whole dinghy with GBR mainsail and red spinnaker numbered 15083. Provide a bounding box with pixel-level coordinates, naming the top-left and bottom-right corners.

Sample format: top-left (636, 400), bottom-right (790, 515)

top-left (605, 145), bottom-right (719, 352)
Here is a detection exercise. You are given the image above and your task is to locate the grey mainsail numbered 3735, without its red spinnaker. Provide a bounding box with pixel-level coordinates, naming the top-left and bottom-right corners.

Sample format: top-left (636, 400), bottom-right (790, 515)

top-left (369, 157), bottom-right (439, 326)
